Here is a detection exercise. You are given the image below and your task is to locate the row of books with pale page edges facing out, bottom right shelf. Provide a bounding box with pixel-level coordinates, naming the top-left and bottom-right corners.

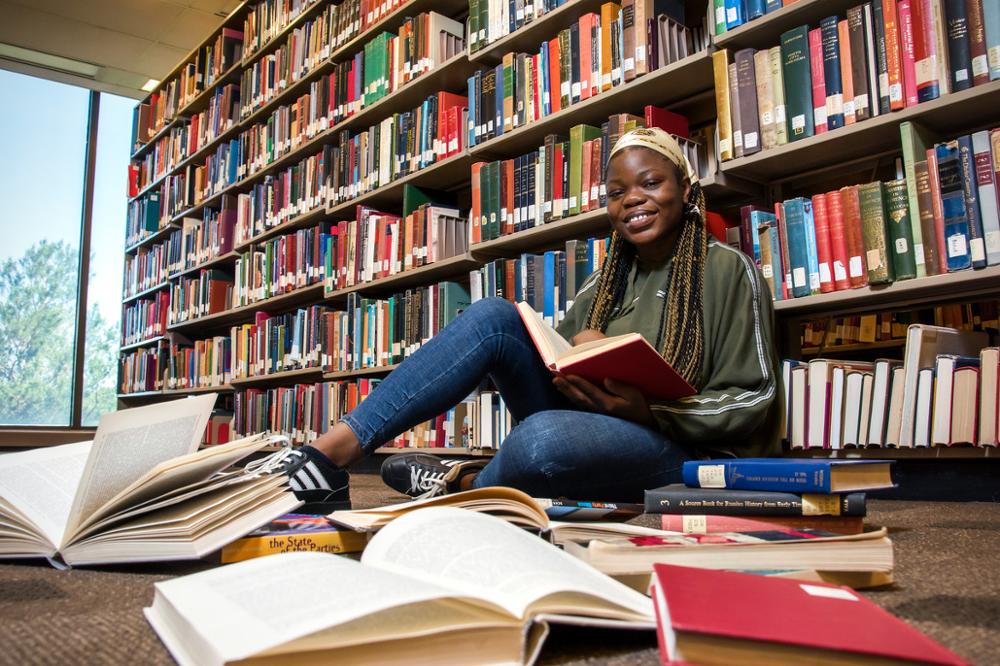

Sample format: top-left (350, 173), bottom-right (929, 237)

top-left (783, 324), bottom-right (1000, 449)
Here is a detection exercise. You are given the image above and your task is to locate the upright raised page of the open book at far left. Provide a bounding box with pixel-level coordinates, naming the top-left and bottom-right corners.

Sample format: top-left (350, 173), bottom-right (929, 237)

top-left (66, 393), bottom-right (216, 535)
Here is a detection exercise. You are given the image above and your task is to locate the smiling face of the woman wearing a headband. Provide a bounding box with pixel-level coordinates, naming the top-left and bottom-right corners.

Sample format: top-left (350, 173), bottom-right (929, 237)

top-left (607, 146), bottom-right (691, 259)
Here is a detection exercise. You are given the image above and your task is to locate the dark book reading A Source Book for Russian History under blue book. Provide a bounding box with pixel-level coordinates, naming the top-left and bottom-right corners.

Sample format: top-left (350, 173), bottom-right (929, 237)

top-left (645, 486), bottom-right (866, 517)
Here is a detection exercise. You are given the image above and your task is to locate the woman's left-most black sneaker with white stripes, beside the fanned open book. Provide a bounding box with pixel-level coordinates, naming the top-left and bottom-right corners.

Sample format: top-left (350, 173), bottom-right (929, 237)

top-left (247, 446), bottom-right (351, 515)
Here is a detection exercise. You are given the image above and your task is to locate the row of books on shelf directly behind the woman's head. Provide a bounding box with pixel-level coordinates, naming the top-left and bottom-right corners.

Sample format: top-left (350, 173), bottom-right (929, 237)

top-left (471, 105), bottom-right (705, 243)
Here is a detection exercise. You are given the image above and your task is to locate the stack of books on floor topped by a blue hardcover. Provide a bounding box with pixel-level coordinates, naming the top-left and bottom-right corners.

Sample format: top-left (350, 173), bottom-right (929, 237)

top-left (566, 458), bottom-right (893, 587)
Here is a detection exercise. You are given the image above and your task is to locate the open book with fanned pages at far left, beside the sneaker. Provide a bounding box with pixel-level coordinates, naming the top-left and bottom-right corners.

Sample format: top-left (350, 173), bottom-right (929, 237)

top-left (0, 394), bottom-right (301, 565)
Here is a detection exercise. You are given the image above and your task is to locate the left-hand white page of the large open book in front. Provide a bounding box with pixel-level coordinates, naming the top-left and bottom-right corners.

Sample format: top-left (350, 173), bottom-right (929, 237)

top-left (150, 553), bottom-right (490, 662)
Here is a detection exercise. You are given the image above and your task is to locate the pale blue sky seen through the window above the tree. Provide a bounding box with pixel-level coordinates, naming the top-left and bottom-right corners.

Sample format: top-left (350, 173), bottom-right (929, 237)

top-left (0, 71), bottom-right (136, 321)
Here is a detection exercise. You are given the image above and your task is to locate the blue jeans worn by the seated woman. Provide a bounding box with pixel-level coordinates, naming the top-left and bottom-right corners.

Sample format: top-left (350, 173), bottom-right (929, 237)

top-left (343, 298), bottom-right (692, 501)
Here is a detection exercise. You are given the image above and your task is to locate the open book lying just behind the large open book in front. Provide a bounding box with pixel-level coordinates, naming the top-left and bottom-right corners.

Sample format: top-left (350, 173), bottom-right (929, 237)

top-left (328, 486), bottom-right (663, 543)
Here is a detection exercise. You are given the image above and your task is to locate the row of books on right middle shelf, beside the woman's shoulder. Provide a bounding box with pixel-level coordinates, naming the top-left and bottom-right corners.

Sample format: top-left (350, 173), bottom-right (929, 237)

top-left (740, 123), bottom-right (1000, 300)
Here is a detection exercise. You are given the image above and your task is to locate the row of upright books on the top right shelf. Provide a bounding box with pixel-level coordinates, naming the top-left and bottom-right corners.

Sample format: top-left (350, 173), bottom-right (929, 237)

top-left (712, 0), bottom-right (1000, 160)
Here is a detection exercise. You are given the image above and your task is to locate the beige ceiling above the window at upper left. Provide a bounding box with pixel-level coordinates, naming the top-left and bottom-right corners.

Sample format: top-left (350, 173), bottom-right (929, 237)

top-left (0, 0), bottom-right (240, 97)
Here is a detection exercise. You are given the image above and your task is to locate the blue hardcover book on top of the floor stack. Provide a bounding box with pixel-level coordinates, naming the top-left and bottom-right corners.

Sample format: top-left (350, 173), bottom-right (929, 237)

top-left (682, 458), bottom-right (895, 493)
